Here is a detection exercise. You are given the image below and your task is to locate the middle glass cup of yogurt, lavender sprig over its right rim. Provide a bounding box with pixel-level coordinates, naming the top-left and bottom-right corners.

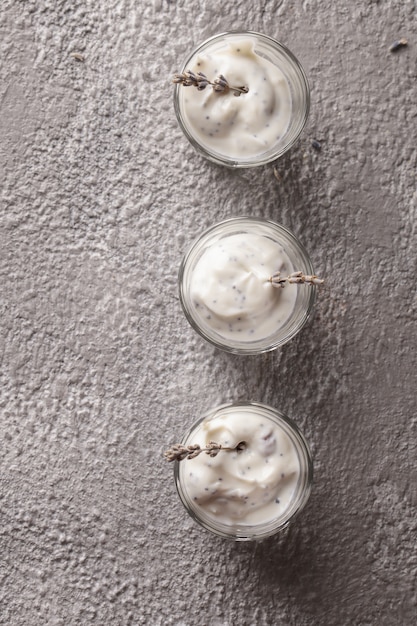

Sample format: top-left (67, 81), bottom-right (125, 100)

top-left (179, 217), bottom-right (317, 354)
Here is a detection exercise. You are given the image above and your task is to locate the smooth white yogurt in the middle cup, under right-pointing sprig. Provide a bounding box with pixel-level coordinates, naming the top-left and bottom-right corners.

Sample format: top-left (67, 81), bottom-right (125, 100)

top-left (189, 233), bottom-right (297, 342)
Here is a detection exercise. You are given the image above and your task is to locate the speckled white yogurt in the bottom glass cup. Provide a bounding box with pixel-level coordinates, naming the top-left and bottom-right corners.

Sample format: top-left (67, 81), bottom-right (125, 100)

top-left (179, 406), bottom-right (306, 527)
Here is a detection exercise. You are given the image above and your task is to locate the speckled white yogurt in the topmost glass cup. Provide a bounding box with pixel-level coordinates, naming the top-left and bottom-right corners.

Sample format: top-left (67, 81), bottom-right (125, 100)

top-left (179, 35), bottom-right (292, 158)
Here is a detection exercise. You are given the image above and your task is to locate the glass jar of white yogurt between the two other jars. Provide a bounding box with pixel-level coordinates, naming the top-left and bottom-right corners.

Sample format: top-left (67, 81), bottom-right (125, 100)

top-left (179, 217), bottom-right (317, 354)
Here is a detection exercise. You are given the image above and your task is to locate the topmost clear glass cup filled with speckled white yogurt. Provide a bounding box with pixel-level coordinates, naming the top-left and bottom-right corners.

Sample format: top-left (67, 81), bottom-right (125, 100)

top-left (174, 31), bottom-right (310, 168)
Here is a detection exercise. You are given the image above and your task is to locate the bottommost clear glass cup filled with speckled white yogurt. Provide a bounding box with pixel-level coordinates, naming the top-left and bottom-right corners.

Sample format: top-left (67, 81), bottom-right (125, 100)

top-left (174, 402), bottom-right (313, 541)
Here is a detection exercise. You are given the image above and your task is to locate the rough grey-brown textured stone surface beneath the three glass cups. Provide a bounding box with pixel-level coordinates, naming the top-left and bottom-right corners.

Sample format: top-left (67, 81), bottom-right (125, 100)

top-left (0, 0), bottom-right (417, 626)
